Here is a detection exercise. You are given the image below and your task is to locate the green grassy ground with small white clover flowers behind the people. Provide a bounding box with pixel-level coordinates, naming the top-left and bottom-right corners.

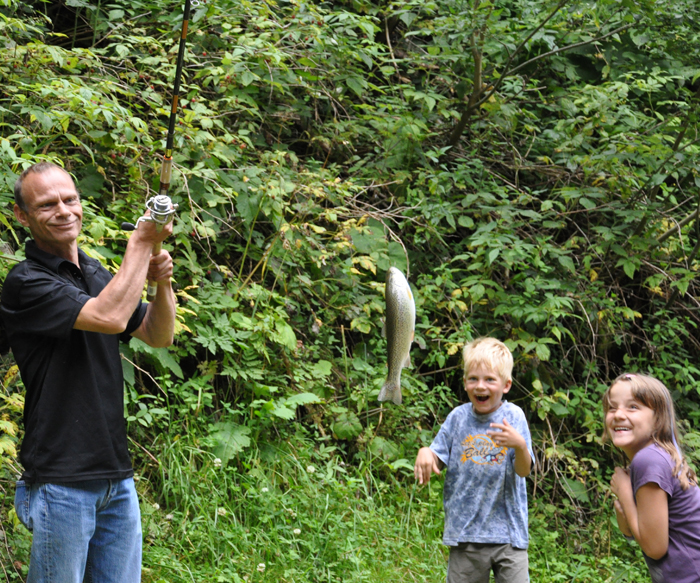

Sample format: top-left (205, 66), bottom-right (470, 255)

top-left (0, 439), bottom-right (649, 583)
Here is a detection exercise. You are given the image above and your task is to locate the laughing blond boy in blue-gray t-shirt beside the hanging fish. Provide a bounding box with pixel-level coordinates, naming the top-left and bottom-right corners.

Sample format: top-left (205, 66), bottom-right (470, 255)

top-left (414, 338), bottom-right (532, 583)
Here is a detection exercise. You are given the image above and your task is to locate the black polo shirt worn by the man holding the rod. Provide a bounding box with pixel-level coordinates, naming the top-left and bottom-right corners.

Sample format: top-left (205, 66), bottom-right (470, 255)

top-left (0, 241), bottom-right (146, 482)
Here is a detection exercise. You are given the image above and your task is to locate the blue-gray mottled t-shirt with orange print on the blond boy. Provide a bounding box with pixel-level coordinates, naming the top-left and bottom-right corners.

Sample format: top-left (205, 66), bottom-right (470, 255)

top-left (430, 401), bottom-right (534, 549)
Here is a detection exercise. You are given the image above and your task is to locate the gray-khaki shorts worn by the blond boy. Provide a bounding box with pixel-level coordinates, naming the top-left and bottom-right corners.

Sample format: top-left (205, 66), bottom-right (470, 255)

top-left (447, 543), bottom-right (530, 583)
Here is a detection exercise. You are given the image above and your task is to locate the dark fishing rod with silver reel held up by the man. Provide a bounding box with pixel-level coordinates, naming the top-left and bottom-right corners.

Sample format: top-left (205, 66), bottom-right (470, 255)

top-left (122, 0), bottom-right (203, 302)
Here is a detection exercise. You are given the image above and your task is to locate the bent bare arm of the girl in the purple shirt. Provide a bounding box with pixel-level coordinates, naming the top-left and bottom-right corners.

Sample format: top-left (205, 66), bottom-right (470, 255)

top-left (610, 468), bottom-right (668, 559)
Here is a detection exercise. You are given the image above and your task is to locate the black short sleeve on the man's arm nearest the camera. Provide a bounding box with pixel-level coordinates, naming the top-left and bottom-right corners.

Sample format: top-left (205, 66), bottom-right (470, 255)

top-left (0, 273), bottom-right (90, 338)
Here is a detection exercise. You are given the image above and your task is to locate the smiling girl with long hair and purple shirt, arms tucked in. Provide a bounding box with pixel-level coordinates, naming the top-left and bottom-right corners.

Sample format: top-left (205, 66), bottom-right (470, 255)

top-left (603, 374), bottom-right (700, 583)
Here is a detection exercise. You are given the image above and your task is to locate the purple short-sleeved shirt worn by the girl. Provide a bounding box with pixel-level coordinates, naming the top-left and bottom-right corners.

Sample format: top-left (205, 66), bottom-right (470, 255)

top-left (630, 444), bottom-right (700, 583)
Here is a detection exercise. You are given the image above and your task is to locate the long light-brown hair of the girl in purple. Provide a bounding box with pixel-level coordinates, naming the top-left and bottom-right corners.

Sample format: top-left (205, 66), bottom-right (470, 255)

top-left (603, 373), bottom-right (697, 490)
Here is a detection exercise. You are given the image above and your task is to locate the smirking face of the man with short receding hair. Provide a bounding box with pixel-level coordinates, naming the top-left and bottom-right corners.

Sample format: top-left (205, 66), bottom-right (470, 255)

top-left (14, 168), bottom-right (83, 256)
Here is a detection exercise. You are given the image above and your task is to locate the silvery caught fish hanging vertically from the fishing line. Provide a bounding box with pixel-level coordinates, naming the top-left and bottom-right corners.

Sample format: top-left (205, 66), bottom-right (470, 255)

top-left (377, 267), bottom-right (416, 405)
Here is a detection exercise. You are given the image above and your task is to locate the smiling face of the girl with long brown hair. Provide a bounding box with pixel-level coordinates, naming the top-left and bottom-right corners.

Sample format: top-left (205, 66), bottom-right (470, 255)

top-left (605, 381), bottom-right (654, 459)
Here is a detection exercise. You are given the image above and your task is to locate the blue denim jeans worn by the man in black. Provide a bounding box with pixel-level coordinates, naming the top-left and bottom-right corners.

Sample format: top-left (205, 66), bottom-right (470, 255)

top-left (15, 478), bottom-right (142, 583)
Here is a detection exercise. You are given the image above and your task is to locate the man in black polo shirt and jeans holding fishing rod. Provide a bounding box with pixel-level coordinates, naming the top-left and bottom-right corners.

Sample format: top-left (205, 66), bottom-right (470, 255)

top-left (0, 162), bottom-right (175, 583)
